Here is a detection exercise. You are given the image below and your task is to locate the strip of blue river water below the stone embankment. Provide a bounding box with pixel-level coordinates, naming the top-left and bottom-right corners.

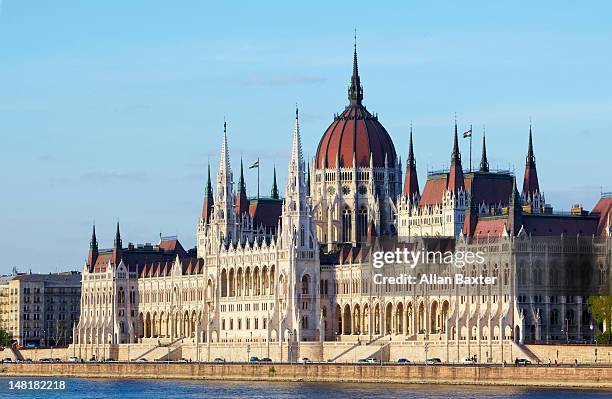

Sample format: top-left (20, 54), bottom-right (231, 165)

top-left (0, 378), bottom-right (612, 399)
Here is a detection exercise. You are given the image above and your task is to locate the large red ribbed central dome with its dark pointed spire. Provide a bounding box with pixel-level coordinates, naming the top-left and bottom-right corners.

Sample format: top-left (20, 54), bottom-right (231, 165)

top-left (315, 46), bottom-right (397, 169)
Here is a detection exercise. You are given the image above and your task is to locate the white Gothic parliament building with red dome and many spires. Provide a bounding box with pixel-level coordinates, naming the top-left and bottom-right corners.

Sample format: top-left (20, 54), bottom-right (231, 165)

top-left (74, 47), bottom-right (612, 361)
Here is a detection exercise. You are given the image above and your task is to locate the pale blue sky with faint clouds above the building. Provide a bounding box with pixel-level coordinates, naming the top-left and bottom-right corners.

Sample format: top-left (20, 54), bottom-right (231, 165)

top-left (0, 0), bottom-right (612, 274)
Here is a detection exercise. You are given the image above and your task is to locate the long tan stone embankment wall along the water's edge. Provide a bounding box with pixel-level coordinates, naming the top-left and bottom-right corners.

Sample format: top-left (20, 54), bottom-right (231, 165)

top-left (0, 363), bottom-right (612, 390)
